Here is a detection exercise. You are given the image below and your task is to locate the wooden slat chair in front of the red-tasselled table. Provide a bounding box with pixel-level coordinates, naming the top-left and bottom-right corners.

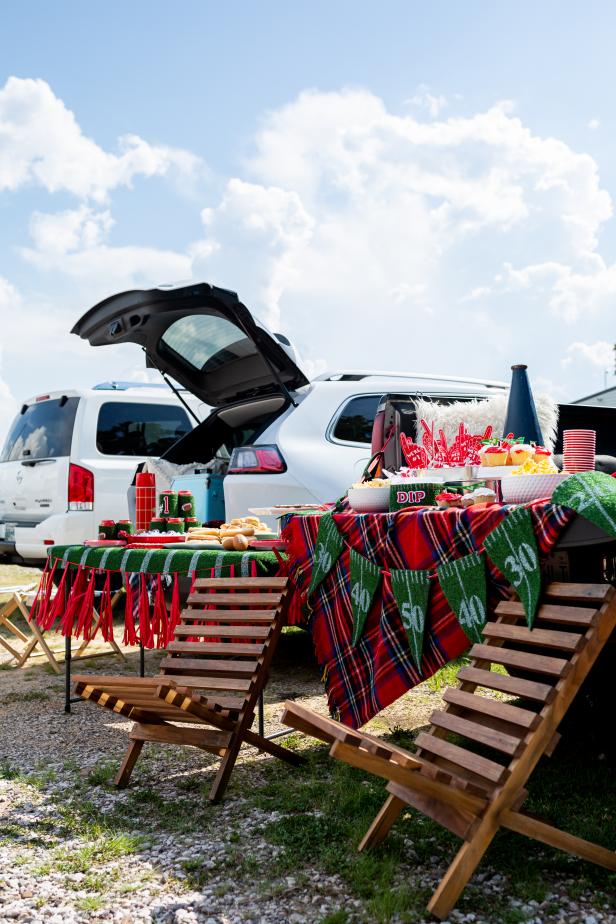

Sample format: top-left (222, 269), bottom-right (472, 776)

top-left (75, 578), bottom-right (301, 802)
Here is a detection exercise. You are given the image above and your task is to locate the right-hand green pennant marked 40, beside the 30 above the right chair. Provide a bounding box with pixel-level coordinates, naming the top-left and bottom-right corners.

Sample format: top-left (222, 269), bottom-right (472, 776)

top-left (437, 552), bottom-right (487, 642)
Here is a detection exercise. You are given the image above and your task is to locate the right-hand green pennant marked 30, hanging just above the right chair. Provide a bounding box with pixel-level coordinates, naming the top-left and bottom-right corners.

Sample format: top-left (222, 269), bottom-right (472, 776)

top-left (484, 507), bottom-right (541, 627)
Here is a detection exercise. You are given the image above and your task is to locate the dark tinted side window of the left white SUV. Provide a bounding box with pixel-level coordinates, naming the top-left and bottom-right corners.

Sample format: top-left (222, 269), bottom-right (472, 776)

top-left (96, 401), bottom-right (191, 456)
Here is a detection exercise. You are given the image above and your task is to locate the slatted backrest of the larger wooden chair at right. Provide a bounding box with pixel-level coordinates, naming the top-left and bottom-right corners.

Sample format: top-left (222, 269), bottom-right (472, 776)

top-left (416, 583), bottom-right (616, 798)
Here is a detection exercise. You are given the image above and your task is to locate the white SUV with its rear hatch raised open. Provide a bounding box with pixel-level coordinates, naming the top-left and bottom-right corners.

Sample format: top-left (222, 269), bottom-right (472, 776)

top-left (73, 283), bottom-right (506, 518)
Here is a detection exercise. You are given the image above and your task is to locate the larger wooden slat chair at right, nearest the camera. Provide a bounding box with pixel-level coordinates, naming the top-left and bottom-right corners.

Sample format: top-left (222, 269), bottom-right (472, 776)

top-left (283, 583), bottom-right (616, 919)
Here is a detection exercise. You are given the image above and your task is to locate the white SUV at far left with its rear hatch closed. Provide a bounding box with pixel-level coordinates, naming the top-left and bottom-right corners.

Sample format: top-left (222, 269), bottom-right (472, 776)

top-left (0, 382), bottom-right (196, 561)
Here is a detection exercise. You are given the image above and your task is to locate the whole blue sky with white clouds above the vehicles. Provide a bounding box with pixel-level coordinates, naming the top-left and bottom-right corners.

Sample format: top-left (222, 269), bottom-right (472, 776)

top-left (0, 0), bottom-right (616, 430)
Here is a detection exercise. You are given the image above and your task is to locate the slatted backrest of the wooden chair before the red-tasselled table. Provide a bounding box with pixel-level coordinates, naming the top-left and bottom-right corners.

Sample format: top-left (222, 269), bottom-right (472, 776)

top-left (155, 577), bottom-right (288, 714)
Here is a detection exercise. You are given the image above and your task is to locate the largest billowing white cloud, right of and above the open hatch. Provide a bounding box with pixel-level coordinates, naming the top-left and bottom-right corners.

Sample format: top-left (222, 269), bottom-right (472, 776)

top-left (192, 82), bottom-right (612, 390)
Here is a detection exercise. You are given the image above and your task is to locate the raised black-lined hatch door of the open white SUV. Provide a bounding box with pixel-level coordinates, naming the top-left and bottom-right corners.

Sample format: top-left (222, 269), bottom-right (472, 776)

top-left (72, 282), bottom-right (309, 408)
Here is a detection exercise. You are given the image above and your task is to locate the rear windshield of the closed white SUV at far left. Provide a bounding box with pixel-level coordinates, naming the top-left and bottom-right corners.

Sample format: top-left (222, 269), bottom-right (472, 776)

top-left (0, 396), bottom-right (79, 462)
